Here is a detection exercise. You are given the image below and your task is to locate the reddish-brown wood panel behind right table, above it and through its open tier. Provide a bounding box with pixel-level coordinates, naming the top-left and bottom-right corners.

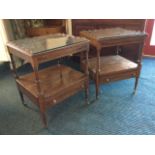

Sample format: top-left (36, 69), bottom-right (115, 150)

top-left (72, 19), bottom-right (146, 61)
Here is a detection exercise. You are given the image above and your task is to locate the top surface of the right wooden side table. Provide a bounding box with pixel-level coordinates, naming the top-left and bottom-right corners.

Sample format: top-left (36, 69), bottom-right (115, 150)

top-left (80, 27), bottom-right (146, 40)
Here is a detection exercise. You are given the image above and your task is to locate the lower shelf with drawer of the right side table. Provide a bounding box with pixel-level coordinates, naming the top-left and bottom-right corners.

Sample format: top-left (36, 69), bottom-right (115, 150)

top-left (82, 55), bottom-right (139, 83)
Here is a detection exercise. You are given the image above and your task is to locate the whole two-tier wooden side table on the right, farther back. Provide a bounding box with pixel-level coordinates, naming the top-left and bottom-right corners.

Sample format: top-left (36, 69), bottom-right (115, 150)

top-left (80, 27), bottom-right (146, 98)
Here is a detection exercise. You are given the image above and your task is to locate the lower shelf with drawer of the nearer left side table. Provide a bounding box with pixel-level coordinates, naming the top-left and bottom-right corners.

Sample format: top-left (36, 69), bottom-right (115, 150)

top-left (16, 65), bottom-right (87, 104)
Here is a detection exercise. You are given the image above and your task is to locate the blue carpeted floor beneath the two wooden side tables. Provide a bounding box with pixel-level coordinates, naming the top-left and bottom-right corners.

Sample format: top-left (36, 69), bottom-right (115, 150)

top-left (0, 58), bottom-right (155, 135)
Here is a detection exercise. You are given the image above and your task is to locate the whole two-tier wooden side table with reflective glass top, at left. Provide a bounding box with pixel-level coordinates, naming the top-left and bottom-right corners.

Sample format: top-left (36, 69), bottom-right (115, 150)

top-left (7, 34), bottom-right (89, 127)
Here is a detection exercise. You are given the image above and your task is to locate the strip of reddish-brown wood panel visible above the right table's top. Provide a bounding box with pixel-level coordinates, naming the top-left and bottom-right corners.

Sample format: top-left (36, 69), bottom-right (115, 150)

top-left (72, 19), bottom-right (145, 35)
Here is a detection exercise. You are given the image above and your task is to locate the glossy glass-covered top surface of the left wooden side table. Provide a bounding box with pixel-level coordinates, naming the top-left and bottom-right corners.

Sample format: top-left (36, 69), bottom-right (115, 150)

top-left (7, 33), bottom-right (86, 54)
